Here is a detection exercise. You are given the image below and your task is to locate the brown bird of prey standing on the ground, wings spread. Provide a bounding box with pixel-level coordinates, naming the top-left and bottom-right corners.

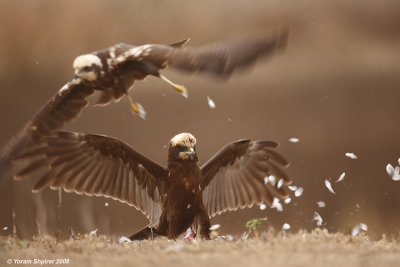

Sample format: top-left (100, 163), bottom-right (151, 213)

top-left (14, 132), bottom-right (292, 240)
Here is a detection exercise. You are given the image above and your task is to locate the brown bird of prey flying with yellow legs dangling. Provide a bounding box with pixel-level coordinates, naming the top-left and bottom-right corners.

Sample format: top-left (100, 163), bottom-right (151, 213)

top-left (0, 29), bottom-right (288, 182)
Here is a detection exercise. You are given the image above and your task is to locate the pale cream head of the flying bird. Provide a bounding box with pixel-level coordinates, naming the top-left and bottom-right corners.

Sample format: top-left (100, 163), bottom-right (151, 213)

top-left (72, 54), bottom-right (103, 82)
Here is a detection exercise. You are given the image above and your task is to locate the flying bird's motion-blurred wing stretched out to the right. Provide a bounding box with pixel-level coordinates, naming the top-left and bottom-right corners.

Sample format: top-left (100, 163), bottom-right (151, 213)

top-left (117, 29), bottom-right (289, 76)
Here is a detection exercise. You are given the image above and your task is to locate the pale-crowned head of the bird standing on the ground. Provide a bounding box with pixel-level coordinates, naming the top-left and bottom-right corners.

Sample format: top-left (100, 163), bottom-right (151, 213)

top-left (168, 133), bottom-right (197, 162)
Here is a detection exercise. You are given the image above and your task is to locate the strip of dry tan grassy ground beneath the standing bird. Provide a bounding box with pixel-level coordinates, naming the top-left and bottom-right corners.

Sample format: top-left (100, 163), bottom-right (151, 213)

top-left (0, 230), bottom-right (400, 267)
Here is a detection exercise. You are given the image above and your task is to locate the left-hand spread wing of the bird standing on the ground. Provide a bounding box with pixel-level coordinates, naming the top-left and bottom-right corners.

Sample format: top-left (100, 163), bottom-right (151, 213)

top-left (15, 132), bottom-right (167, 226)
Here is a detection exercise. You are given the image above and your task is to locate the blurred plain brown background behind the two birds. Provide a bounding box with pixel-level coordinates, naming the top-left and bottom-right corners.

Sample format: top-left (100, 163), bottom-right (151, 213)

top-left (0, 0), bottom-right (400, 238)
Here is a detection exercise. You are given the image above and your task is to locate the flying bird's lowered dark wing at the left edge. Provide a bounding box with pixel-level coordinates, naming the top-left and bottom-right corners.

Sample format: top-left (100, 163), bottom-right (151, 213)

top-left (0, 79), bottom-right (94, 184)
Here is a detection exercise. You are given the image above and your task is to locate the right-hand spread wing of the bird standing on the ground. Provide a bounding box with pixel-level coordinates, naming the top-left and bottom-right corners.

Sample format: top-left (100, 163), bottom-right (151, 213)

top-left (201, 140), bottom-right (292, 217)
